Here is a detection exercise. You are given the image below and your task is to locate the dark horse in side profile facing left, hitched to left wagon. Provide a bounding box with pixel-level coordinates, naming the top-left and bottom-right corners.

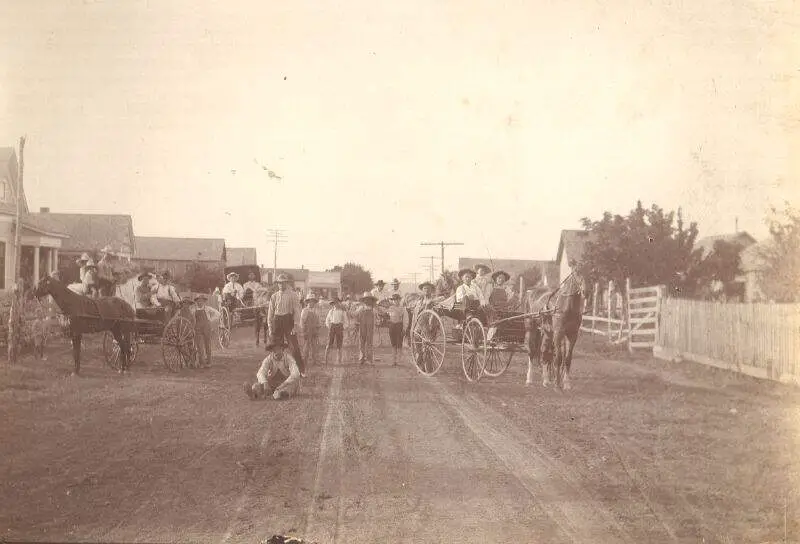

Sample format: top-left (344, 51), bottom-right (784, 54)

top-left (33, 276), bottom-right (136, 376)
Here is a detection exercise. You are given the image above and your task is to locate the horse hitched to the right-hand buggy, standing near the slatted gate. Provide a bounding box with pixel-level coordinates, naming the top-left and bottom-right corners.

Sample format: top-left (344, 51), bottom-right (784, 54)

top-left (525, 281), bottom-right (583, 390)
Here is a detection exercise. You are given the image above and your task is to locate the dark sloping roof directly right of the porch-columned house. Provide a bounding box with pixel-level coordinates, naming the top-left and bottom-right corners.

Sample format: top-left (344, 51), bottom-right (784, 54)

top-left (28, 212), bottom-right (135, 253)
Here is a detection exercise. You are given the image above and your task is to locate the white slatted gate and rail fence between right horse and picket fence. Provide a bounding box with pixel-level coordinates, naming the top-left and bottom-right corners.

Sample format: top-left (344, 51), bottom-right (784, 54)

top-left (581, 280), bottom-right (666, 351)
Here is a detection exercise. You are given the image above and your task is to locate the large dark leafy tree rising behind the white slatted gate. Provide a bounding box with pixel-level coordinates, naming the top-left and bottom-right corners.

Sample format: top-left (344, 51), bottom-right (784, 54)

top-left (578, 201), bottom-right (697, 294)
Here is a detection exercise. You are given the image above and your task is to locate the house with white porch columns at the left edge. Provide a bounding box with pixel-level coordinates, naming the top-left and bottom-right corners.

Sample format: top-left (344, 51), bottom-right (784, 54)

top-left (0, 147), bottom-right (69, 290)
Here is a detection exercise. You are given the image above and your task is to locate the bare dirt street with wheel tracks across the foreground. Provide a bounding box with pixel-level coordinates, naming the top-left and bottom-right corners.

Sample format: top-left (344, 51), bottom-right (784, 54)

top-left (0, 330), bottom-right (800, 543)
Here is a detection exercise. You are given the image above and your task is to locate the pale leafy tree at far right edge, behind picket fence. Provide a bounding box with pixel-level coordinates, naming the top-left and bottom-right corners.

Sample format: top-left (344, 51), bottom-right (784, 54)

top-left (759, 204), bottom-right (800, 302)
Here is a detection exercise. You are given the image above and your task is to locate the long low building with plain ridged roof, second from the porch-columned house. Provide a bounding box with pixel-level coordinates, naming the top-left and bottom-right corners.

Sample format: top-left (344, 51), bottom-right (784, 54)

top-left (133, 236), bottom-right (225, 281)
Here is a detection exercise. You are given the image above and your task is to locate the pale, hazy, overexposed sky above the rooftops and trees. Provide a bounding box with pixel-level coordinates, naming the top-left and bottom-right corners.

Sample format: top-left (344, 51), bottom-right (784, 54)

top-left (0, 0), bottom-right (800, 280)
